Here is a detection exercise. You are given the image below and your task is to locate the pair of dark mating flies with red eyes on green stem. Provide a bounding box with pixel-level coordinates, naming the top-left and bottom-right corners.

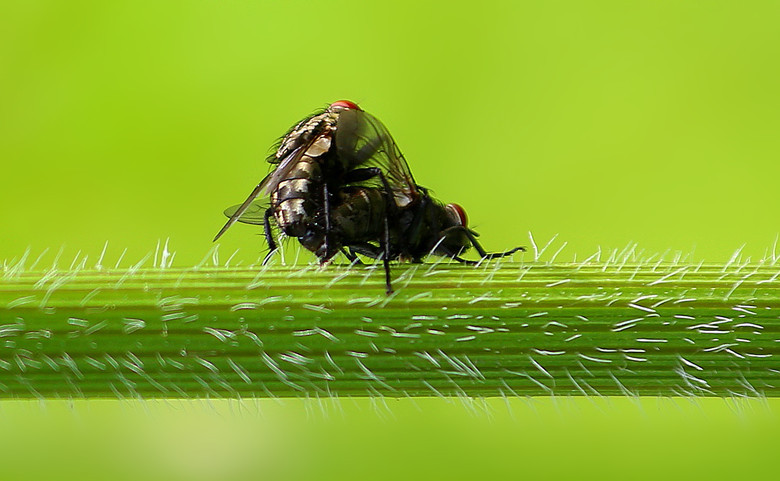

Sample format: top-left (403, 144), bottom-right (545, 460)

top-left (214, 100), bottom-right (524, 293)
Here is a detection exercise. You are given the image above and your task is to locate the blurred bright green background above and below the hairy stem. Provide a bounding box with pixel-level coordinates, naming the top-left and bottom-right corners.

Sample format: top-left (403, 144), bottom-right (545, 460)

top-left (0, 0), bottom-right (780, 479)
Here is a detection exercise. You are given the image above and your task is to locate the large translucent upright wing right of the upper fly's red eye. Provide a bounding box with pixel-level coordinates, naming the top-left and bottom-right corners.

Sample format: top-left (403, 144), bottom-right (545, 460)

top-left (336, 109), bottom-right (418, 207)
